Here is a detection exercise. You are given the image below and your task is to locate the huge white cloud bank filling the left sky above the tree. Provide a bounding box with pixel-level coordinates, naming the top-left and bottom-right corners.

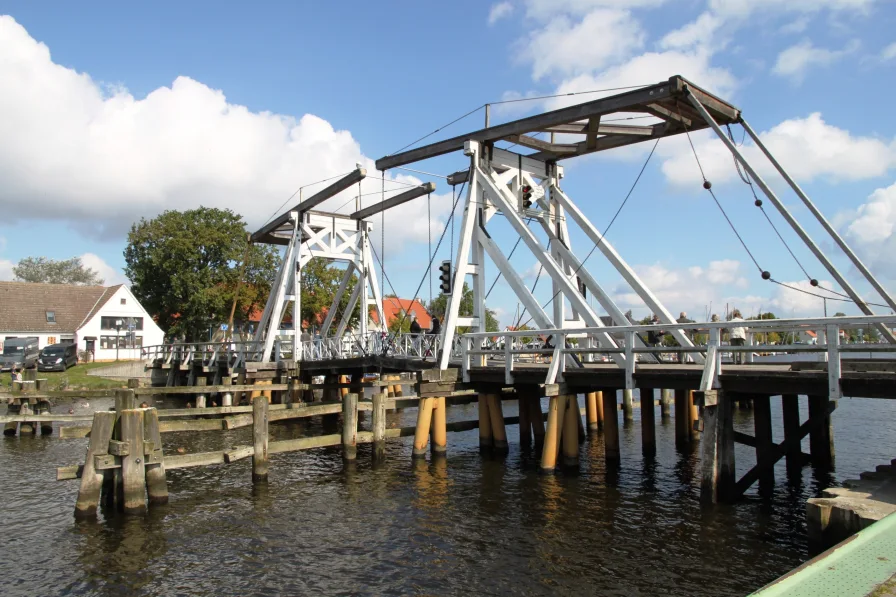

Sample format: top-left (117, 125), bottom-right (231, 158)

top-left (0, 16), bottom-right (449, 253)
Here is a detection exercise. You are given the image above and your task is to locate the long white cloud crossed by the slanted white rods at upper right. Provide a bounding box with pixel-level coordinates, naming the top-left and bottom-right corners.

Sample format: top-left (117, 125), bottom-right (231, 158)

top-left (658, 112), bottom-right (896, 186)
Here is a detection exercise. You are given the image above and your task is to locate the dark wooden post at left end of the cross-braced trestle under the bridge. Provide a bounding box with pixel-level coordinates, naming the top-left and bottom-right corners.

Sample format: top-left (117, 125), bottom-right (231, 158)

top-left (700, 390), bottom-right (735, 503)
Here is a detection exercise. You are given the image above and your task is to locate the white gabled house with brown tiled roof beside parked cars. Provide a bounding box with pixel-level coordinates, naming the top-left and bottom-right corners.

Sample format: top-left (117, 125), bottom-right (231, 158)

top-left (0, 282), bottom-right (164, 361)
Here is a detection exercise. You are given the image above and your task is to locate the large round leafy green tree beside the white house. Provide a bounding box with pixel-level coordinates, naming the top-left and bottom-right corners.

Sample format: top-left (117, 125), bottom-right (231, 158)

top-left (124, 207), bottom-right (280, 340)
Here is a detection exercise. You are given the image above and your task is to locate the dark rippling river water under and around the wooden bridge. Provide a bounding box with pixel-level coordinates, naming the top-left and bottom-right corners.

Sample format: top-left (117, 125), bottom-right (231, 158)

top-left (0, 398), bottom-right (896, 597)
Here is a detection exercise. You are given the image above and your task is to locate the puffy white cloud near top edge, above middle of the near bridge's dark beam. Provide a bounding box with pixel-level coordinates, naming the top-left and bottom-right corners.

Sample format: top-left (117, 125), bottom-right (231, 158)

top-left (521, 9), bottom-right (644, 81)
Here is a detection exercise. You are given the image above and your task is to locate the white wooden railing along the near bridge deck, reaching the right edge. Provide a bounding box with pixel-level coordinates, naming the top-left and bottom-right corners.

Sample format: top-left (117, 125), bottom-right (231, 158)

top-left (459, 315), bottom-right (896, 399)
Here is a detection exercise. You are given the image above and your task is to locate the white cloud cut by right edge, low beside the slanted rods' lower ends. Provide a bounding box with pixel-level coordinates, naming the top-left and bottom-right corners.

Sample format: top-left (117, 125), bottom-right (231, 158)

top-left (835, 183), bottom-right (896, 280)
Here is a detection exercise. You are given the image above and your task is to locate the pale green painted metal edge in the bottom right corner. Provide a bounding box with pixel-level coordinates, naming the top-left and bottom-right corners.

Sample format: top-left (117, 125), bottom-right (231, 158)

top-left (752, 513), bottom-right (896, 597)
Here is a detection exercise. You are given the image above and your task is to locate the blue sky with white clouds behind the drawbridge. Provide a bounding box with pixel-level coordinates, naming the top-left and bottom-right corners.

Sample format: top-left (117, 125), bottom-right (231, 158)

top-left (0, 0), bottom-right (896, 325)
